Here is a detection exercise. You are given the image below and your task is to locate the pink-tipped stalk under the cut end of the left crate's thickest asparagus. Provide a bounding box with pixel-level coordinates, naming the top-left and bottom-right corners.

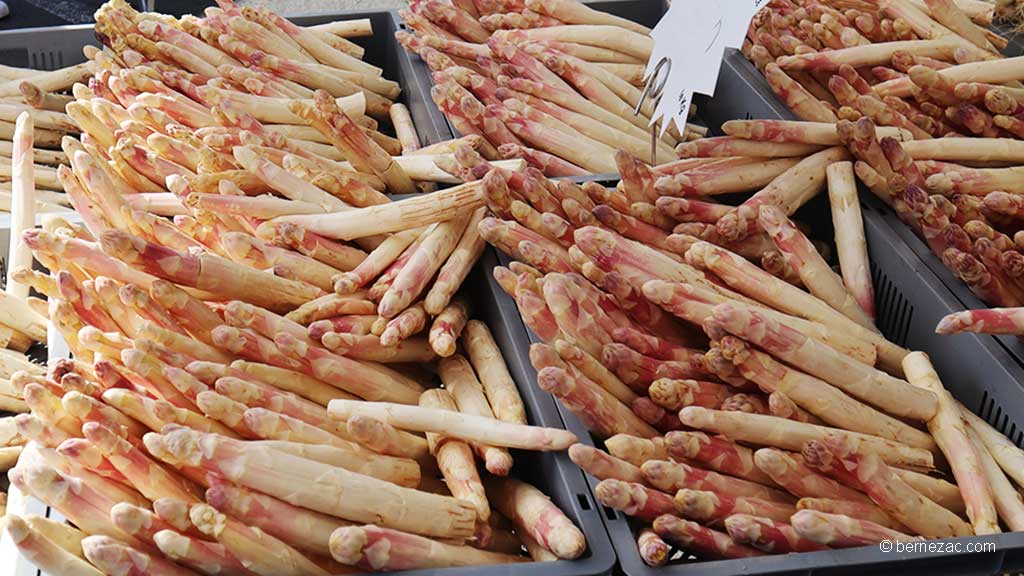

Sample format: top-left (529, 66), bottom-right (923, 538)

top-left (331, 525), bottom-right (527, 571)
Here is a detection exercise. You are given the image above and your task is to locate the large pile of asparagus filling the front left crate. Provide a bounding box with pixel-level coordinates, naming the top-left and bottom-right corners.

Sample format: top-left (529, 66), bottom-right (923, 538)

top-left (5, 174), bottom-right (586, 576)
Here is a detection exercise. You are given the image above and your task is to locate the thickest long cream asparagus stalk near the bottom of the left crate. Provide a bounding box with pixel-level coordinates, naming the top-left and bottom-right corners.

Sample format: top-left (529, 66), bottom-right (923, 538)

top-left (144, 428), bottom-right (476, 538)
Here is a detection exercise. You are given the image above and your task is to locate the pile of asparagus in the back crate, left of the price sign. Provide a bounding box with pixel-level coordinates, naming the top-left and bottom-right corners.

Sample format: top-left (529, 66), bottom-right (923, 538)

top-left (396, 0), bottom-right (706, 177)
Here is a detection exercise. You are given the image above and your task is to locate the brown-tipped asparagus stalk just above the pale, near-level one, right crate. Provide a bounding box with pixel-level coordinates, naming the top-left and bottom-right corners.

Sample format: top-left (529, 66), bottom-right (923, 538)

top-left (719, 336), bottom-right (937, 450)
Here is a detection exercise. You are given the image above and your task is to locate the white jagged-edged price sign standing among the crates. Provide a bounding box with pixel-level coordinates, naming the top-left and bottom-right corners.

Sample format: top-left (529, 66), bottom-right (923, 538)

top-left (644, 0), bottom-right (769, 134)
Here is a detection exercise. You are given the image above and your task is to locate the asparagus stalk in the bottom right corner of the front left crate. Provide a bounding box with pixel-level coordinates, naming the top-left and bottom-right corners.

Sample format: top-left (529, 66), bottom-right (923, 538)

top-left (485, 478), bottom-right (587, 560)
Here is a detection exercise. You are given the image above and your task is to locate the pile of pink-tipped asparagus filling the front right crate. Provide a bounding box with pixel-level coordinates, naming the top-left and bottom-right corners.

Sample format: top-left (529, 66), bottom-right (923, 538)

top-left (480, 120), bottom-right (1024, 566)
